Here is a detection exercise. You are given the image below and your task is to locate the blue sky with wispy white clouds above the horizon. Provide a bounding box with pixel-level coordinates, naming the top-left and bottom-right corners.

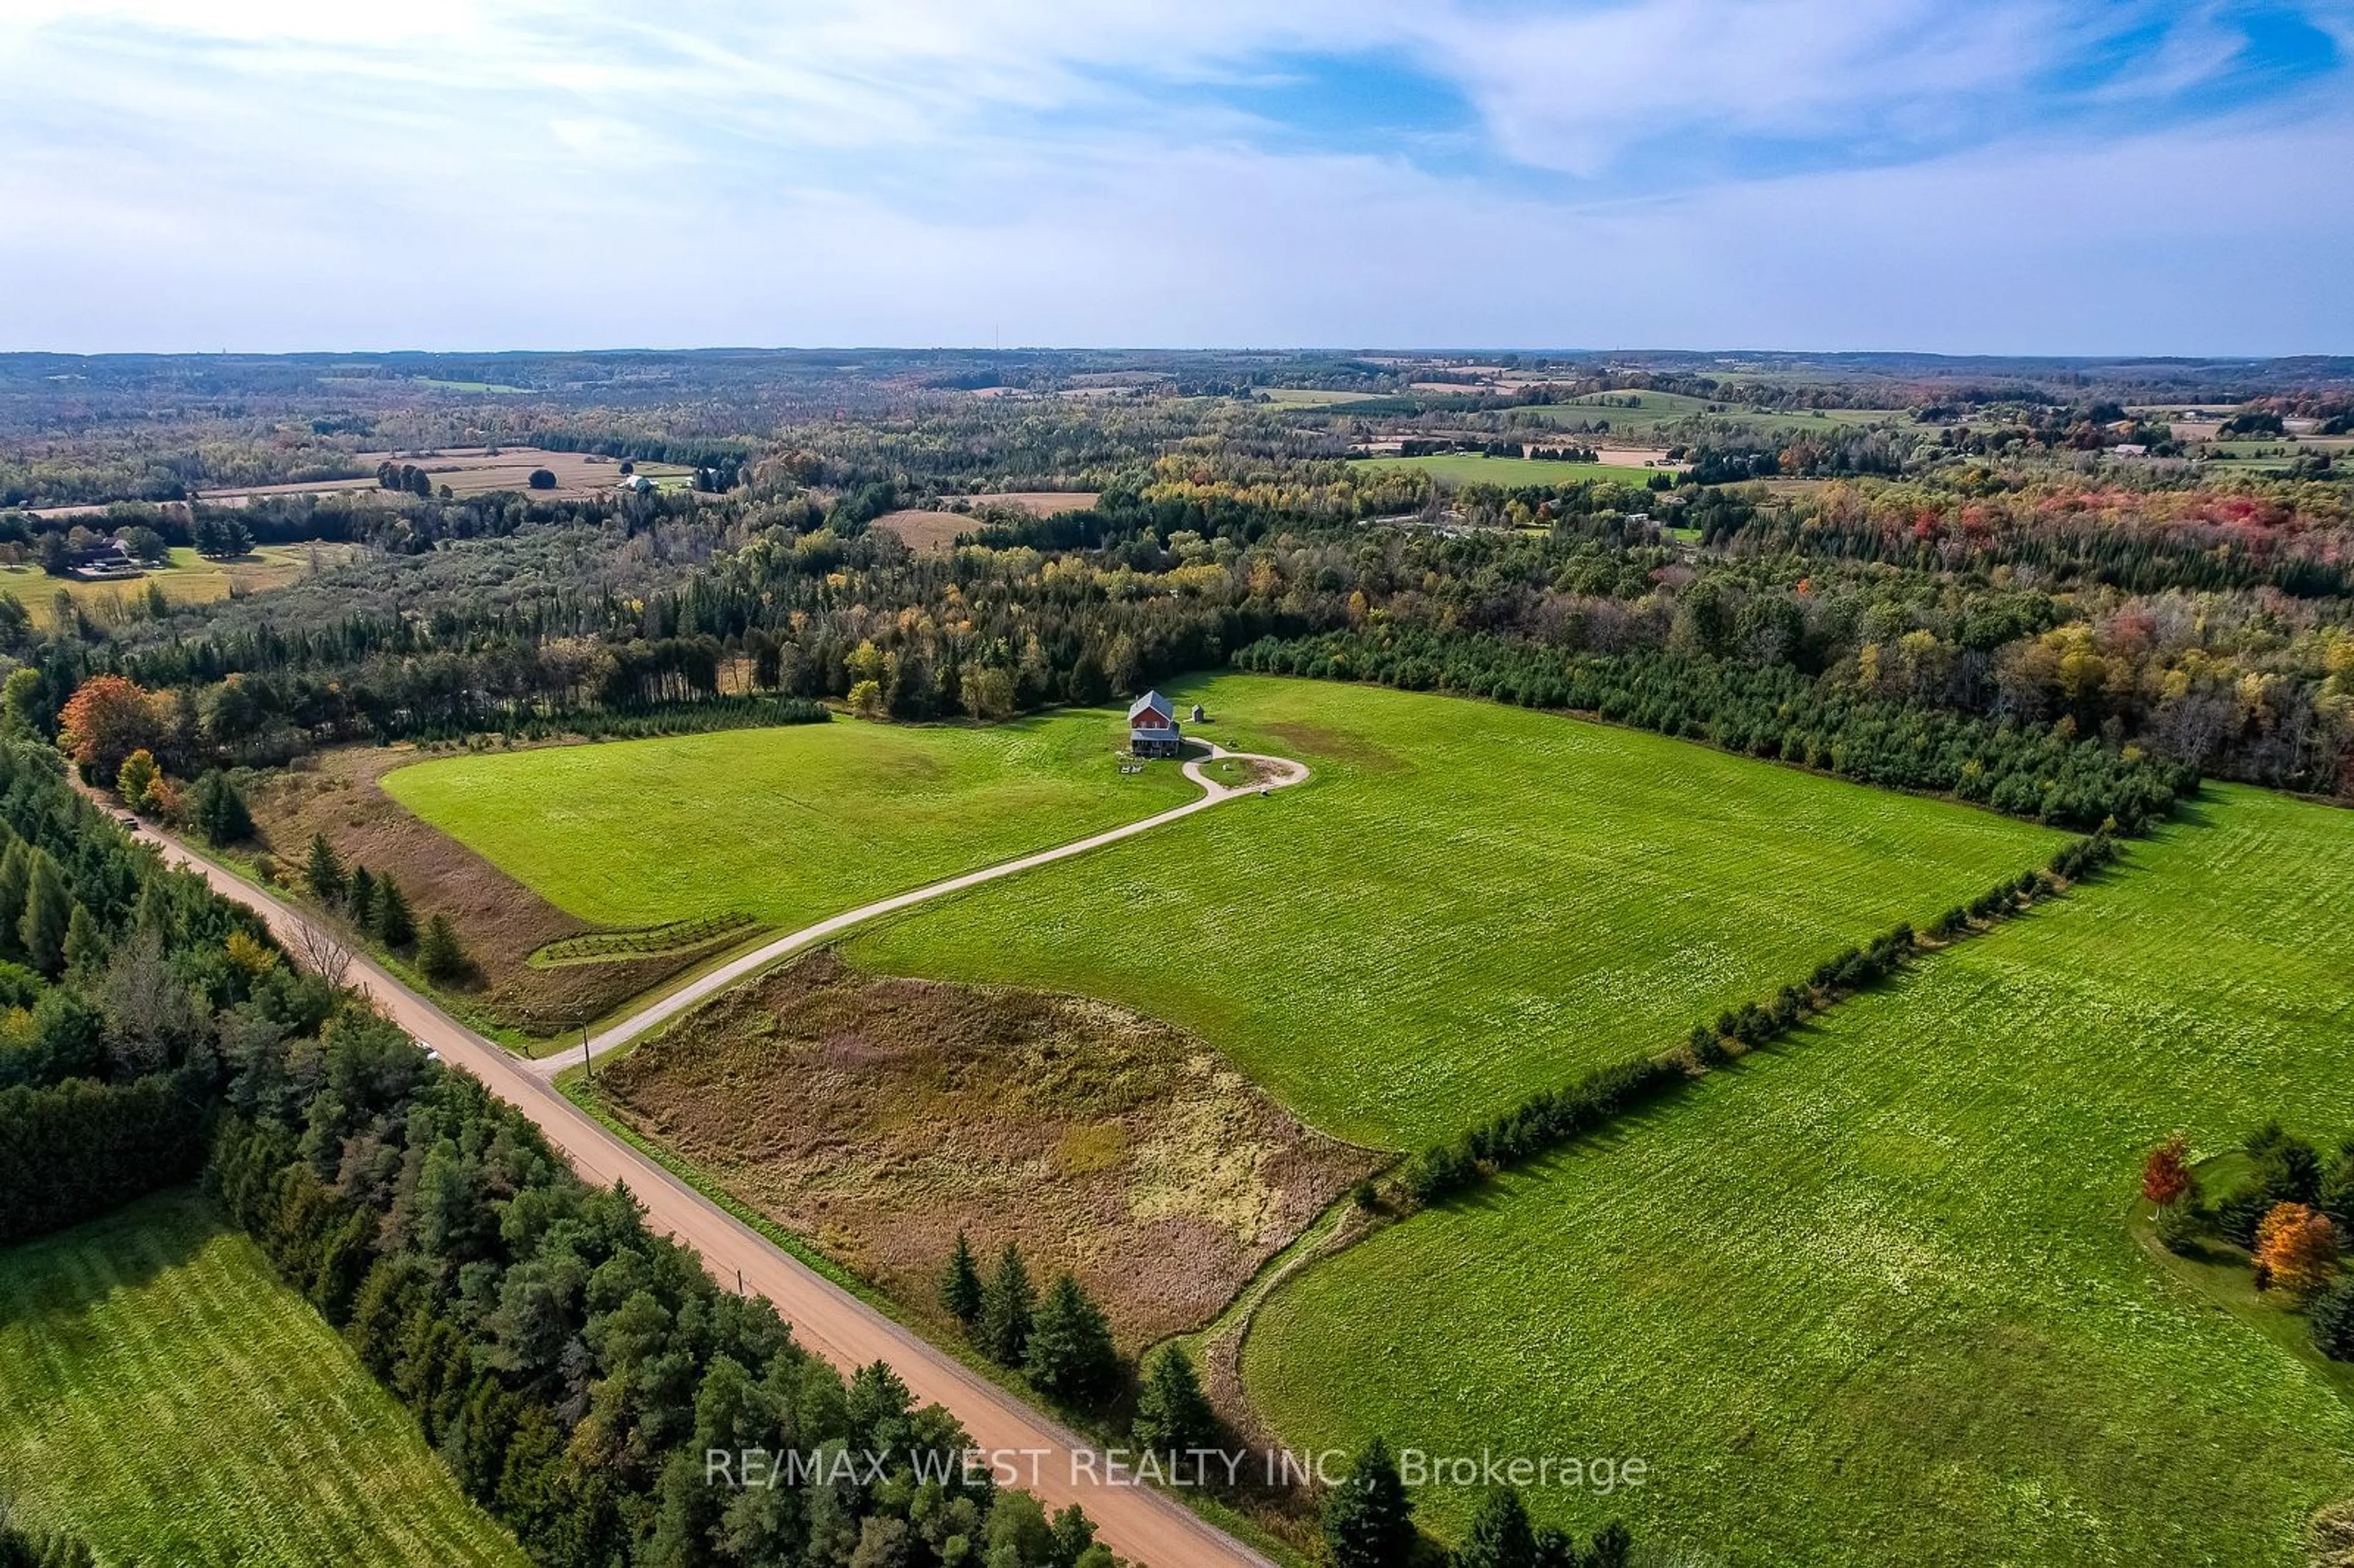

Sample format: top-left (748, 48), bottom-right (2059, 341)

top-left (0, 0), bottom-right (2354, 353)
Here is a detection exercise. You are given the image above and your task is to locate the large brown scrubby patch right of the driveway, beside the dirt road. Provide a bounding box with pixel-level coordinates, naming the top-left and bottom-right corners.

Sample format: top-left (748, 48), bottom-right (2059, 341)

top-left (598, 951), bottom-right (1382, 1349)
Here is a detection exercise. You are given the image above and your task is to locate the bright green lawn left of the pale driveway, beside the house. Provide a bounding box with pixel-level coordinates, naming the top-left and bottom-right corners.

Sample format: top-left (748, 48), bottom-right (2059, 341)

top-left (384, 711), bottom-right (1200, 927)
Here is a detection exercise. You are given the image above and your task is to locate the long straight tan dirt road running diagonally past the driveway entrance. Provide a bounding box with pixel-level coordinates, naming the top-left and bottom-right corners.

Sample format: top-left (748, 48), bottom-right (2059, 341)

top-left (139, 824), bottom-right (1304, 1568)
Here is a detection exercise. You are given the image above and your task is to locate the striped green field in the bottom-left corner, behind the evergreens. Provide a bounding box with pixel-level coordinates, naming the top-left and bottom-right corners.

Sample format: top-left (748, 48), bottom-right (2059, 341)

top-left (0, 1191), bottom-right (525, 1568)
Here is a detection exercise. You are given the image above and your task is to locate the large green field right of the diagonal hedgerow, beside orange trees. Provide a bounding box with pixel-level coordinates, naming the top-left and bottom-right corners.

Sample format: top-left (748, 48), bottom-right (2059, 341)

top-left (1245, 786), bottom-right (2354, 1568)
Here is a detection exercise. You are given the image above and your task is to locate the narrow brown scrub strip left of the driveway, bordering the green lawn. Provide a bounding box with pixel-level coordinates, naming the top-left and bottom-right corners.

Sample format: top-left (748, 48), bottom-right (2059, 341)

top-left (245, 747), bottom-right (725, 1036)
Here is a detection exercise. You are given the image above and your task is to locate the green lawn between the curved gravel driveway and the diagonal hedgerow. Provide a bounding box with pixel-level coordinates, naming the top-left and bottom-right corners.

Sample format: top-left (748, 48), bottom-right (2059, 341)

top-left (850, 676), bottom-right (2065, 1146)
